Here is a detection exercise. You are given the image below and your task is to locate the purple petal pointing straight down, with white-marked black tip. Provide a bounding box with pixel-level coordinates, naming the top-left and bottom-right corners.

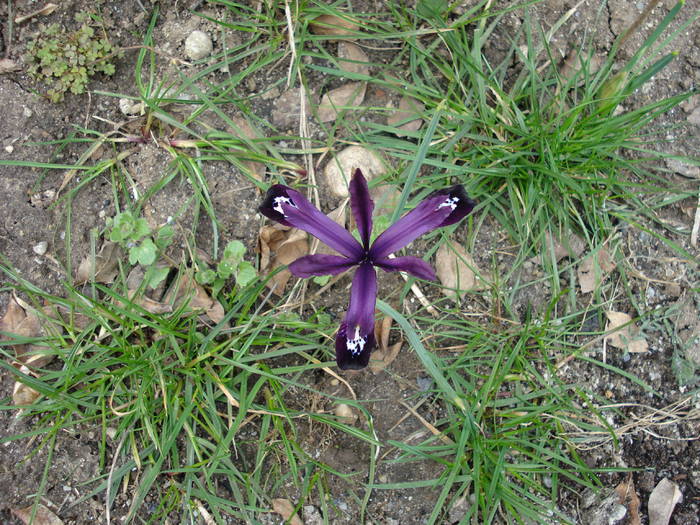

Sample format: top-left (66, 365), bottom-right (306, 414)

top-left (335, 262), bottom-right (377, 370)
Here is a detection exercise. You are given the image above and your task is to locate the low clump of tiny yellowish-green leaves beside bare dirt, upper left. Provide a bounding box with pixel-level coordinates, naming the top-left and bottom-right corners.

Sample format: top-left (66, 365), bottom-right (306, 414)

top-left (25, 11), bottom-right (115, 102)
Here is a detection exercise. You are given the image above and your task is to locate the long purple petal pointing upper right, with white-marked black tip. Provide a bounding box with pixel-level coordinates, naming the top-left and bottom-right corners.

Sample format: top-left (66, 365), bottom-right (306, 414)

top-left (370, 186), bottom-right (476, 261)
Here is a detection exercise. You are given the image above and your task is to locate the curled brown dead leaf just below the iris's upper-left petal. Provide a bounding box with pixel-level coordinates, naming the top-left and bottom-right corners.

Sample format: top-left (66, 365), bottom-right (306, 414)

top-left (258, 224), bottom-right (309, 296)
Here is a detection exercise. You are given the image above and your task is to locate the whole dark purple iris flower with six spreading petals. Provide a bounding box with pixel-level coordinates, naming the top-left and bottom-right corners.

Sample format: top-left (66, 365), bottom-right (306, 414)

top-left (259, 169), bottom-right (476, 370)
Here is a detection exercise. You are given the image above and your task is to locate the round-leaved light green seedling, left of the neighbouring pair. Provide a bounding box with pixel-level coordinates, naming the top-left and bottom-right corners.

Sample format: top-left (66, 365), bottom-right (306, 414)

top-left (107, 211), bottom-right (174, 266)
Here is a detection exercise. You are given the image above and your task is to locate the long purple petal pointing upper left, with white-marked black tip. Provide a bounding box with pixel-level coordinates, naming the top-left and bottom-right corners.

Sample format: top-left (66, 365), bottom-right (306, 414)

top-left (258, 184), bottom-right (363, 261)
